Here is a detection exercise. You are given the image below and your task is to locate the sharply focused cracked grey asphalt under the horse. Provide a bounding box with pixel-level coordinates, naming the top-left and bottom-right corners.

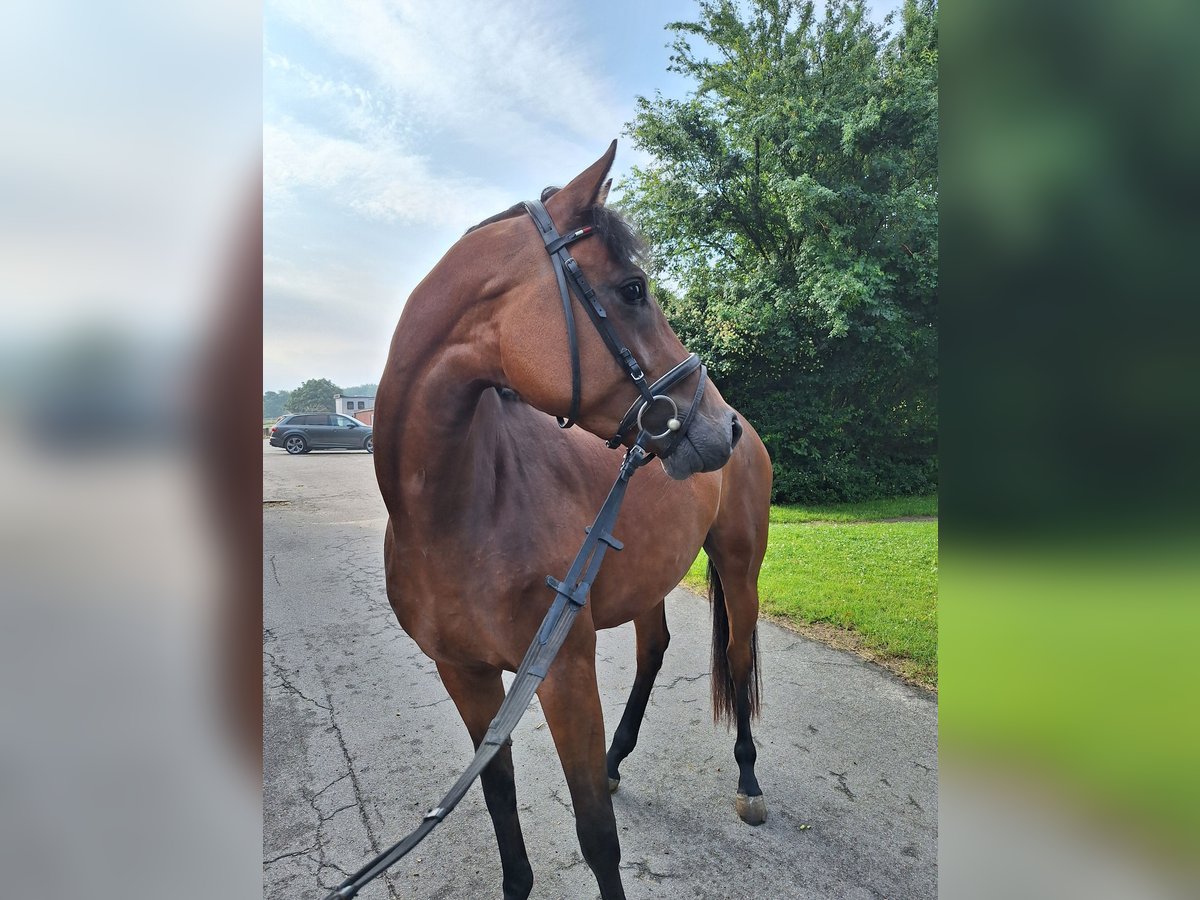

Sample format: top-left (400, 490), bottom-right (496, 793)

top-left (263, 442), bottom-right (937, 900)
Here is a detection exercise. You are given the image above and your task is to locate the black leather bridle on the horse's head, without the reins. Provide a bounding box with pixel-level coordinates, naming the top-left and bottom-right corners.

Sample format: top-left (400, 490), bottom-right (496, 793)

top-left (524, 200), bottom-right (708, 458)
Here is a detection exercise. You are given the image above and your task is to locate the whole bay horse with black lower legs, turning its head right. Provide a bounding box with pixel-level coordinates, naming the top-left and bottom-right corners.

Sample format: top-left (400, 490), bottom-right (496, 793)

top-left (374, 140), bottom-right (770, 900)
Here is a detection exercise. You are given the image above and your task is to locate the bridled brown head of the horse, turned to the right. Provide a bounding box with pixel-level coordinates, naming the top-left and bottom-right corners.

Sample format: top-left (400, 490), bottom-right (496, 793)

top-left (492, 140), bottom-right (742, 479)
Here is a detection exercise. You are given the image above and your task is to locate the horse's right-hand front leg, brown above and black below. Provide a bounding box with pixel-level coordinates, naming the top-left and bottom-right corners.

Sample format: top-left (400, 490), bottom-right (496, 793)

top-left (538, 628), bottom-right (625, 900)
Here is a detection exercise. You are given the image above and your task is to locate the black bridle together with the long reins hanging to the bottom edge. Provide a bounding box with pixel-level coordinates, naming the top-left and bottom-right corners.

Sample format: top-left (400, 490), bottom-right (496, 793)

top-left (325, 200), bottom-right (707, 900)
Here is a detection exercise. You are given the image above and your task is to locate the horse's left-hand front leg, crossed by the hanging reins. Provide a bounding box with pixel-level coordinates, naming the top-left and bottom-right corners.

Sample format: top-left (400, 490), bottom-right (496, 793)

top-left (438, 662), bottom-right (533, 900)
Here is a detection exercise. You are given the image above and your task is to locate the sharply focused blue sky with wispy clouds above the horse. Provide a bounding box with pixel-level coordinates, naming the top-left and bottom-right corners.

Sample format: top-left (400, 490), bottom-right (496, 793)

top-left (263, 0), bottom-right (899, 390)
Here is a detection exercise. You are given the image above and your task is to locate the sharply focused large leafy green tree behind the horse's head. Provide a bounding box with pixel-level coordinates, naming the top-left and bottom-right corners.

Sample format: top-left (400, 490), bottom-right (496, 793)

top-left (623, 0), bottom-right (937, 502)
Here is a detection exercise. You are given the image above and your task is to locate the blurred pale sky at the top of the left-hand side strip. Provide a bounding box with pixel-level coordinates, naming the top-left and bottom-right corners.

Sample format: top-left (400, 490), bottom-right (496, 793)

top-left (0, 0), bottom-right (262, 340)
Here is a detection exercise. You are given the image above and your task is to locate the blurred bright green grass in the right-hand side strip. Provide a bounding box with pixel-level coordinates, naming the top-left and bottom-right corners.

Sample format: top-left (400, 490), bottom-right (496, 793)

top-left (938, 535), bottom-right (1200, 848)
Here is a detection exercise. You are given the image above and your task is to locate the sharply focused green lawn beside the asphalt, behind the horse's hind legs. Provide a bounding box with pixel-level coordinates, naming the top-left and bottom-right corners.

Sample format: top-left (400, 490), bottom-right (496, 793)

top-left (685, 497), bottom-right (937, 686)
